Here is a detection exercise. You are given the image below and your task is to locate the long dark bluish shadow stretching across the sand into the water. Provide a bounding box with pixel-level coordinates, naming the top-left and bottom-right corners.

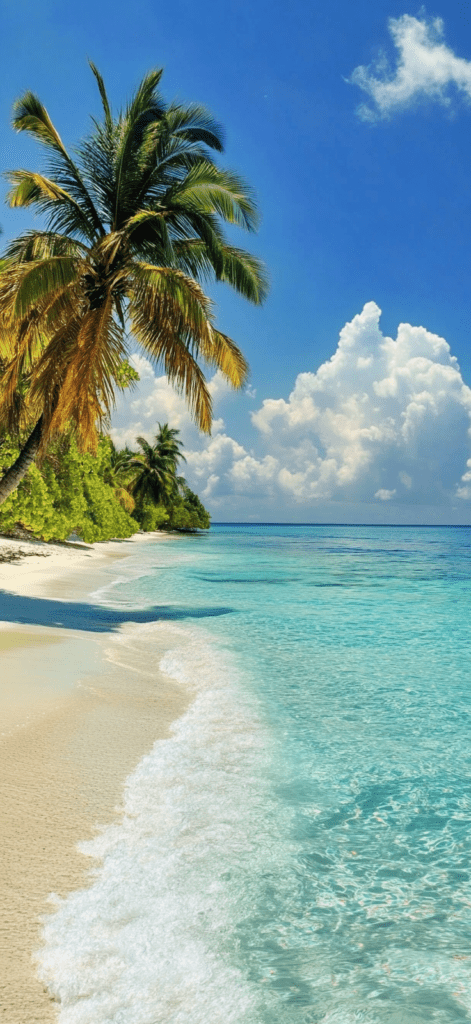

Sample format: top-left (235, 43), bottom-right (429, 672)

top-left (0, 590), bottom-right (233, 633)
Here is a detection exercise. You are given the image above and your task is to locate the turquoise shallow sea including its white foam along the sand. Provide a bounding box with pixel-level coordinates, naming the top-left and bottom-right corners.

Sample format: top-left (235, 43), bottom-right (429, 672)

top-left (41, 526), bottom-right (471, 1024)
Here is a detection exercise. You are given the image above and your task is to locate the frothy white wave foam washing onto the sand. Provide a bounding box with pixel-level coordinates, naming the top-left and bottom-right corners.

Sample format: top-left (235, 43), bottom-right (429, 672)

top-left (38, 625), bottom-right (274, 1024)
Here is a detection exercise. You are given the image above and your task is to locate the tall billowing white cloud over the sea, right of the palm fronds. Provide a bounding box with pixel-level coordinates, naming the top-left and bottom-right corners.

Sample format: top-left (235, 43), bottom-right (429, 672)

top-left (248, 302), bottom-right (471, 505)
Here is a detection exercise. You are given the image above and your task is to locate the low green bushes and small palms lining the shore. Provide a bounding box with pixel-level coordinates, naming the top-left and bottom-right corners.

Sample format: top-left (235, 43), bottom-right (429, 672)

top-left (0, 424), bottom-right (211, 543)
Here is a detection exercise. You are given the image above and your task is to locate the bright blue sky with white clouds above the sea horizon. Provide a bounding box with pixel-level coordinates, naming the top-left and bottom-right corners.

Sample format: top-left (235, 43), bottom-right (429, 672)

top-left (0, 0), bottom-right (471, 522)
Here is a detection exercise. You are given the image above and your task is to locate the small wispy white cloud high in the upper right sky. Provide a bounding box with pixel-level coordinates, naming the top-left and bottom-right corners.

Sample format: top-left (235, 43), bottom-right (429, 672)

top-left (349, 14), bottom-right (471, 121)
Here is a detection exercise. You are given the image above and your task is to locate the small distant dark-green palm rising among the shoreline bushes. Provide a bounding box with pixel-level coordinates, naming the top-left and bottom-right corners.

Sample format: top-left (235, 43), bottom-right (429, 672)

top-left (129, 424), bottom-right (185, 507)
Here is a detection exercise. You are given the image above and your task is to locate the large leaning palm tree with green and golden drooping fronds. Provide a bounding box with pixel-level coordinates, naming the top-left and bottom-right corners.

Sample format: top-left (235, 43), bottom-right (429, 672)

top-left (0, 65), bottom-right (266, 503)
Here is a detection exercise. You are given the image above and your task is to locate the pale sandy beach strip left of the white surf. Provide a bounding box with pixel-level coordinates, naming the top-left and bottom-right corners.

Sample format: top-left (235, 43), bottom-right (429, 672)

top-left (0, 537), bottom-right (188, 1024)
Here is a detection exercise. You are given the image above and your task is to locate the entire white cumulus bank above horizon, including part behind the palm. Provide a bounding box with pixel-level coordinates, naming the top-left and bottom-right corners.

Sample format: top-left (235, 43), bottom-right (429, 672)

top-left (112, 302), bottom-right (471, 519)
